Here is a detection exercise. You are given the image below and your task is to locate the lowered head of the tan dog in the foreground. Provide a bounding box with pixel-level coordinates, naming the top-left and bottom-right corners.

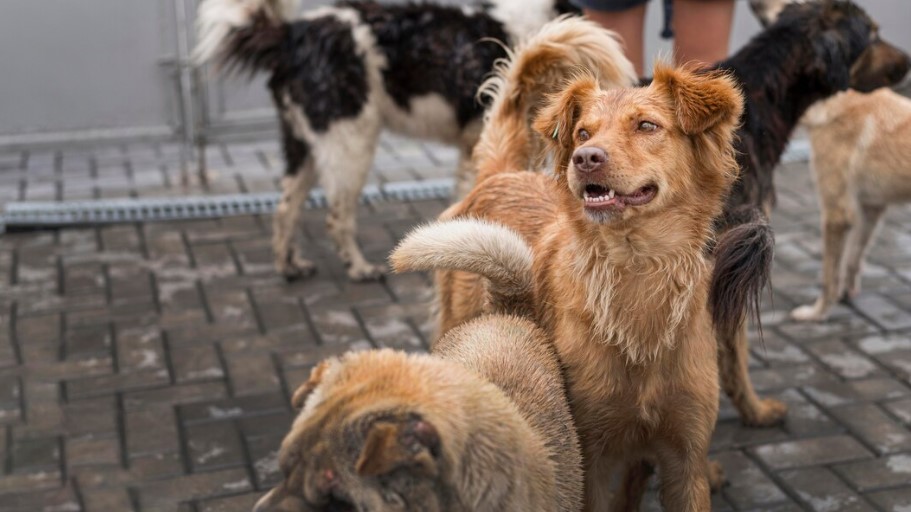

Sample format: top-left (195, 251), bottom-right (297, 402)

top-left (254, 351), bottom-right (451, 512)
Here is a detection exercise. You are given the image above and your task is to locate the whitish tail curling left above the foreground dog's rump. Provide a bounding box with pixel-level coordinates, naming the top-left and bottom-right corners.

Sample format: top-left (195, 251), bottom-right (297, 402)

top-left (389, 219), bottom-right (533, 315)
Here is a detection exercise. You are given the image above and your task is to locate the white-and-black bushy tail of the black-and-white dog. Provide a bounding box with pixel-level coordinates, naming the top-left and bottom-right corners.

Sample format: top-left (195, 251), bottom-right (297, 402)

top-left (193, 0), bottom-right (300, 72)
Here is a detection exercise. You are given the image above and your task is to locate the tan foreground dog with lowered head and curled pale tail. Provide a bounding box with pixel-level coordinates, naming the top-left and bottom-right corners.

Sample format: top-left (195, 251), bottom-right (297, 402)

top-left (255, 315), bottom-right (582, 512)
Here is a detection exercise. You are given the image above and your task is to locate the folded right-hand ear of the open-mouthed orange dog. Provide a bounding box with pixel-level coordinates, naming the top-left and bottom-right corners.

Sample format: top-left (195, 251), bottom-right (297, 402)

top-left (652, 65), bottom-right (743, 135)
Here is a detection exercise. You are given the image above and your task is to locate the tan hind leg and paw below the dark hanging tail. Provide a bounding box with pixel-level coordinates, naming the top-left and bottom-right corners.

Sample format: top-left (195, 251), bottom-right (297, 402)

top-left (718, 323), bottom-right (788, 427)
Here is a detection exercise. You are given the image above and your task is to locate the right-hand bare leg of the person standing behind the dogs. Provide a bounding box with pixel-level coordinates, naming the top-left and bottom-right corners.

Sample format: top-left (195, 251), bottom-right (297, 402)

top-left (673, 0), bottom-right (734, 66)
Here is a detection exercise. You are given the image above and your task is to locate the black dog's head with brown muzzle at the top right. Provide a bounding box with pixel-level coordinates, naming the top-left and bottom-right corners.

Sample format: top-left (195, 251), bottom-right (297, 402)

top-left (764, 0), bottom-right (911, 92)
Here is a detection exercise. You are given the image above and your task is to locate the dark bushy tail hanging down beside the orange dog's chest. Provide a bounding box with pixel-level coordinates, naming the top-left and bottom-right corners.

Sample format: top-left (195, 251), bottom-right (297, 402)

top-left (709, 208), bottom-right (775, 340)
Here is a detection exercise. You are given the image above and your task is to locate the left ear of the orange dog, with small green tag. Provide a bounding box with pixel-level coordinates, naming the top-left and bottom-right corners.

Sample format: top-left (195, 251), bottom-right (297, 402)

top-left (533, 75), bottom-right (600, 166)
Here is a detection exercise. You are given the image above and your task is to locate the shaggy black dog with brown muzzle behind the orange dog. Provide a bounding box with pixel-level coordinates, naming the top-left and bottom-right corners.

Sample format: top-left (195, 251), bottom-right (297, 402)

top-left (700, 0), bottom-right (908, 426)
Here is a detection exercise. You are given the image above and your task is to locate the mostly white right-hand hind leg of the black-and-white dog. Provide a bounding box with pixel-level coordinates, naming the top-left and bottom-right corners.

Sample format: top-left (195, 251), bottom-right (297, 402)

top-left (314, 120), bottom-right (386, 281)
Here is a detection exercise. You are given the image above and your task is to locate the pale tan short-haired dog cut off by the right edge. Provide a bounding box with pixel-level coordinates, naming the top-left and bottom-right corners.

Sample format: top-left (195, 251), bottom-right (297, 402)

top-left (791, 89), bottom-right (911, 320)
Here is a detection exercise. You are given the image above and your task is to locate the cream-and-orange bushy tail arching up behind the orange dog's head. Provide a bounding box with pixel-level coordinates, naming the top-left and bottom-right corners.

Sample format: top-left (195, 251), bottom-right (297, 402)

top-left (474, 16), bottom-right (636, 182)
